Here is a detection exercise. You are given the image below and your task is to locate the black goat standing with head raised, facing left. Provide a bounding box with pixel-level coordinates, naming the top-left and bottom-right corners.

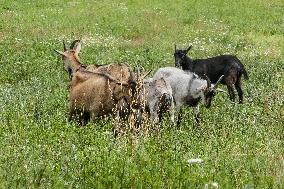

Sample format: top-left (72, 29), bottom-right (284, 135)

top-left (174, 45), bottom-right (248, 103)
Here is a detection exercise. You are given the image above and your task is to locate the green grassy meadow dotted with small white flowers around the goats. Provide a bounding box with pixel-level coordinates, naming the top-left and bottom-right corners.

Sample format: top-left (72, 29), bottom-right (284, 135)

top-left (0, 0), bottom-right (284, 189)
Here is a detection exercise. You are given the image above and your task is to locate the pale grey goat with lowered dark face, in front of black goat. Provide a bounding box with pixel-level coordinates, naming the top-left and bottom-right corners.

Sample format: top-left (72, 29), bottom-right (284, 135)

top-left (153, 67), bottom-right (224, 125)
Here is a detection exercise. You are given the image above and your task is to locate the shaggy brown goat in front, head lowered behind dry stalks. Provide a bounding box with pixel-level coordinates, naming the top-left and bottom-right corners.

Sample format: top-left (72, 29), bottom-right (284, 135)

top-left (69, 70), bottom-right (131, 125)
